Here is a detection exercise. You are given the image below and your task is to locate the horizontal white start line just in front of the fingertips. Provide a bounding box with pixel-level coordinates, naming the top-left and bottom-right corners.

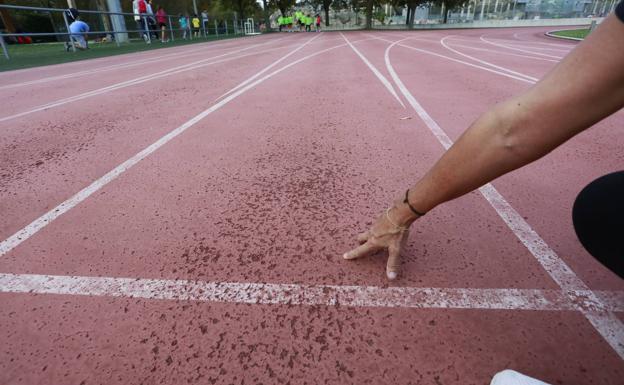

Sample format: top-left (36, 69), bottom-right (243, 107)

top-left (0, 274), bottom-right (622, 311)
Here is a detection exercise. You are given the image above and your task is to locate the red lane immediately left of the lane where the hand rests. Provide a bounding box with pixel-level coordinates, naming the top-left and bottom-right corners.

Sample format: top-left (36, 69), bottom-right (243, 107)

top-left (0, 35), bottom-right (324, 238)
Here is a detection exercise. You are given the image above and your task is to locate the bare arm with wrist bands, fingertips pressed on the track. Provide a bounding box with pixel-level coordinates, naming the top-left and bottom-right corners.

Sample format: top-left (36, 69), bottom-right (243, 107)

top-left (344, 15), bottom-right (624, 279)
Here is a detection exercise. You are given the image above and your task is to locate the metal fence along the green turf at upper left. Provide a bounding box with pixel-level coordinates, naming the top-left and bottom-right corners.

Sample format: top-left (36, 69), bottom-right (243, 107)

top-left (0, 4), bottom-right (258, 59)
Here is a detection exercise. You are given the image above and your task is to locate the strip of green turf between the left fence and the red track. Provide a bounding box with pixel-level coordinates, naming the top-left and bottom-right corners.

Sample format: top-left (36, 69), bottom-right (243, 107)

top-left (0, 35), bottom-right (247, 71)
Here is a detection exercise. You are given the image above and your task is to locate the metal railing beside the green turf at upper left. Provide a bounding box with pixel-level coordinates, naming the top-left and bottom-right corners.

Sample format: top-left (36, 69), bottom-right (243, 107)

top-left (0, 4), bottom-right (254, 59)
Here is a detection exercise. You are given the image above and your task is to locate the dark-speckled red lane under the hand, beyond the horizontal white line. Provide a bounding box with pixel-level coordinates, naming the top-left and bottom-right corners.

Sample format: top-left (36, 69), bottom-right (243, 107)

top-left (3, 35), bottom-right (554, 288)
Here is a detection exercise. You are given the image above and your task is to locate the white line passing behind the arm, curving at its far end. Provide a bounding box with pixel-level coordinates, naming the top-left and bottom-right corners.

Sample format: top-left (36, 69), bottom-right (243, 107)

top-left (385, 40), bottom-right (624, 359)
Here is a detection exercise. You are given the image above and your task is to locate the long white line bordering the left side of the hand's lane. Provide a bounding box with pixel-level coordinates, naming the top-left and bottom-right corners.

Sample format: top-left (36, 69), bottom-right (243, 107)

top-left (0, 39), bottom-right (346, 257)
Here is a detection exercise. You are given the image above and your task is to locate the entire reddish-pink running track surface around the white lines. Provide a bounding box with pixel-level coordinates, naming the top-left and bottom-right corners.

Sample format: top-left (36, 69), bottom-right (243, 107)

top-left (0, 29), bottom-right (624, 384)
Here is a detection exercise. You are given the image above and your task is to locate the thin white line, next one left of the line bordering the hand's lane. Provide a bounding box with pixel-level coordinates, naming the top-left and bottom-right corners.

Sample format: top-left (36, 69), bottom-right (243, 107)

top-left (0, 37), bottom-right (310, 123)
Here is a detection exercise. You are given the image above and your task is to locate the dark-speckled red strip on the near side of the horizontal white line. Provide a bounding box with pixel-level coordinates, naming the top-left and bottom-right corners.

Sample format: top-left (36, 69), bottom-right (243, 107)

top-left (0, 294), bottom-right (622, 385)
